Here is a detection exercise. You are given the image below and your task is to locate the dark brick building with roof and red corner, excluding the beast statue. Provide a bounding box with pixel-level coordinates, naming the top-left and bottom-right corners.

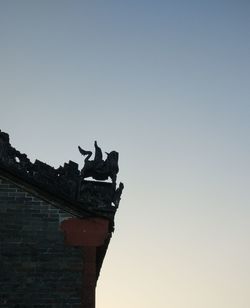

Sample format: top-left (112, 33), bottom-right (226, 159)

top-left (0, 131), bottom-right (123, 308)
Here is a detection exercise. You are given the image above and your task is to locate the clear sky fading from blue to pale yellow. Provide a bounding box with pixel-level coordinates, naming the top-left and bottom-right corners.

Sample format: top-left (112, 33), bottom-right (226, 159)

top-left (0, 0), bottom-right (250, 308)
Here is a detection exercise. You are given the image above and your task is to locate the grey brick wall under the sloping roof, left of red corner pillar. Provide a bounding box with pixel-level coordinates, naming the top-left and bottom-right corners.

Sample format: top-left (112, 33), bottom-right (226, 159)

top-left (0, 177), bottom-right (83, 308)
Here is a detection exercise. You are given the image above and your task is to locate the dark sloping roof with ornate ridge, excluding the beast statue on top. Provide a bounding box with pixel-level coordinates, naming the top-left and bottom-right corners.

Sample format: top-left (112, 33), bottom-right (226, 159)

top-left (0, 130), bottom-right (123, 227)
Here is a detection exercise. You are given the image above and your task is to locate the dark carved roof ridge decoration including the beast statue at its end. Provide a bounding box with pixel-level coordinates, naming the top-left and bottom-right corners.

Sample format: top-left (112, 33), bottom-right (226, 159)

top-left (0, 130), bottom-right (124, 217)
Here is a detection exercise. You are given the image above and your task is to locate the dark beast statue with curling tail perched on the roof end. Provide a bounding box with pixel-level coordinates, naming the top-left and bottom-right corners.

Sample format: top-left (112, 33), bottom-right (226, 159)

top-left (78, 141), bottom-right (119, 183)
